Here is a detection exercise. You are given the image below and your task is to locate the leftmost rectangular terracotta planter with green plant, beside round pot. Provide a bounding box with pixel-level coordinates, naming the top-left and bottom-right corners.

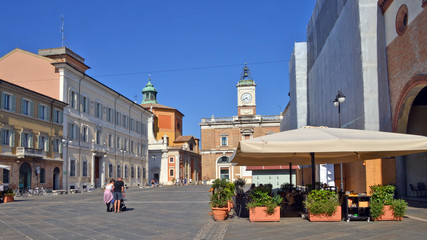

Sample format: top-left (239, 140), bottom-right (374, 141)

top-left (246, 186), bottom-right (283, 222)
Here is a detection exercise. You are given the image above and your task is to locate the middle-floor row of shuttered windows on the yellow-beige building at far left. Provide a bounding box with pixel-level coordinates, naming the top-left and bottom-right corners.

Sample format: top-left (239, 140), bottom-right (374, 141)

top-left (0, 128), bottom-right (62, 152)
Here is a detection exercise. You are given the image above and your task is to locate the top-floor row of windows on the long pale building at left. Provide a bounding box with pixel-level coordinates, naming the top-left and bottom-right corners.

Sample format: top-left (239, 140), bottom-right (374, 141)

top-left (69, 90), bottom-right (147, 135)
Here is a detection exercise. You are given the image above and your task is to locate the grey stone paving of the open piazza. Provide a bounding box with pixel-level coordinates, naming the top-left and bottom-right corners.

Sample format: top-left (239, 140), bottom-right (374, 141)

top-left (0, 186), bottom-right (427, 240)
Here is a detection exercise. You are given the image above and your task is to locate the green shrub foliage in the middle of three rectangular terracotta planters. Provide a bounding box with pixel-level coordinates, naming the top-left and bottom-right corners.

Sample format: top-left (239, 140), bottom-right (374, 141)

top-left (304, 189), bottom-right (340, 216)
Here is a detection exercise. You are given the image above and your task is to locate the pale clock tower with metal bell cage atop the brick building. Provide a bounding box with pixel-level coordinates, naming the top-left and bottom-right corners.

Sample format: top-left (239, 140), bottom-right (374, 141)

top-left (236, 63), bottom-right (256, 117)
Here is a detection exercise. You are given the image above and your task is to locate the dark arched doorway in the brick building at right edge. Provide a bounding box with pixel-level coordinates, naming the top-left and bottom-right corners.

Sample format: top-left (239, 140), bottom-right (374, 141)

top-left (405, 87), bottom-right (427, 197)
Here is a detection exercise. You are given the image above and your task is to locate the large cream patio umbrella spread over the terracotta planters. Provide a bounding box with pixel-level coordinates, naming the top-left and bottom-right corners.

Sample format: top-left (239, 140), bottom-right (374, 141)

top-left (231, 127), bottom-right (427, 186)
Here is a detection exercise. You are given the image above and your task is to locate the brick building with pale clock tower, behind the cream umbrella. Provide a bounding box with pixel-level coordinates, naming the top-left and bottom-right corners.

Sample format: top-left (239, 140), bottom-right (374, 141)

top-left (200, 66), bottom-right (282, 183)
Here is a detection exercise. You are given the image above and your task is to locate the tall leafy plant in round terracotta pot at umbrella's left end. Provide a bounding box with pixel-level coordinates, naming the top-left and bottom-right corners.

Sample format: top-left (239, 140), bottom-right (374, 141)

top-left (210, 179), bottom-right (234, 221)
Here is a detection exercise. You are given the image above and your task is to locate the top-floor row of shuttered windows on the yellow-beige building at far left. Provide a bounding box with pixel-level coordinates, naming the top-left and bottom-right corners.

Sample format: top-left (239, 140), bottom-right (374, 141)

top-left (1, 92), bottom-right (63, 124)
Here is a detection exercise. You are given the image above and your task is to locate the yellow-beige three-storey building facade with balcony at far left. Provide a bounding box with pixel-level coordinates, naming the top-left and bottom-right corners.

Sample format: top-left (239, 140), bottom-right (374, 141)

top-left (0, 80), bottom-right (66, 189)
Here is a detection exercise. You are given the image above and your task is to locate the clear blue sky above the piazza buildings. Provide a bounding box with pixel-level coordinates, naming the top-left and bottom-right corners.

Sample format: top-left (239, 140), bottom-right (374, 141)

top-left (0, 0), bottom-right (316, 137)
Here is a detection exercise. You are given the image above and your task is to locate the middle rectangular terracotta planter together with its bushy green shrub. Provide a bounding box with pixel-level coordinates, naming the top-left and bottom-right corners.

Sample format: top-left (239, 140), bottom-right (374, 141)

top-left (304, 189), bottom-right (341, 222)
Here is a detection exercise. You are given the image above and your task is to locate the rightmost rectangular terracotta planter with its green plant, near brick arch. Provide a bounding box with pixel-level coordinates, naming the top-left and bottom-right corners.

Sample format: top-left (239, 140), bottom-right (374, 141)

top-left (370, 185), bottom-right (408, 221)
